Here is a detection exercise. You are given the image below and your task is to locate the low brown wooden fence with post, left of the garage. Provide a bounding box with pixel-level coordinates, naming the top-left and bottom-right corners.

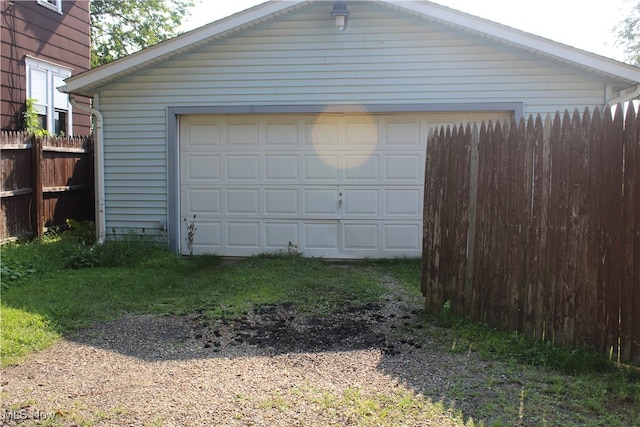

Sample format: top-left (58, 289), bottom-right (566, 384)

top-left (0, 132), bottom-right (94, 241)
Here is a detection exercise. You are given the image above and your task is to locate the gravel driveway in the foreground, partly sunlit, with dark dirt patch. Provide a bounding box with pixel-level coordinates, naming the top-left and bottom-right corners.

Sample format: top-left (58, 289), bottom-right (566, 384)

top-left (1, 283), bottom-right (552, 426)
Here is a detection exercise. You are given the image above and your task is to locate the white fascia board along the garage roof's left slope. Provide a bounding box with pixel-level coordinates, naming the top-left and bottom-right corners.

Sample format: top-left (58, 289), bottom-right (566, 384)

top-left (65, 0), bottom-right (313, 96)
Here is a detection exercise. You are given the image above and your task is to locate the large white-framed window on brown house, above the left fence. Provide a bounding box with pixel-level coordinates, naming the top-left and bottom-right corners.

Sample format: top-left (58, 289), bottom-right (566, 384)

top-left (25, 56), bottom-right (72, 135)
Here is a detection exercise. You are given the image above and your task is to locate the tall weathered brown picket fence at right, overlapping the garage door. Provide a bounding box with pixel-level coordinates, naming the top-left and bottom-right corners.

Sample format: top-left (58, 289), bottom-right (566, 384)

top-left (422, 106), bottom-right (640, 363)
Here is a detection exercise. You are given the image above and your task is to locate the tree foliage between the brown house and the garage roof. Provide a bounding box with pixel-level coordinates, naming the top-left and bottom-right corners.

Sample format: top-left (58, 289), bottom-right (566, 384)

top-left (90, 0), bottom-right (196, 67)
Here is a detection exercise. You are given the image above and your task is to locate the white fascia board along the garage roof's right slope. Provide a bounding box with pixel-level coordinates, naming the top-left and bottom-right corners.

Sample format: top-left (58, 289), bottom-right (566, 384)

top-left (380, 0), bottom-right (640, 83)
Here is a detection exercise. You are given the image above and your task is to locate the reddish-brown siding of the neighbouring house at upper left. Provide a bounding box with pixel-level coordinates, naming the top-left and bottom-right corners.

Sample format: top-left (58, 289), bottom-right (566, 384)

top-left (0, 0), bottom-right (91, 135)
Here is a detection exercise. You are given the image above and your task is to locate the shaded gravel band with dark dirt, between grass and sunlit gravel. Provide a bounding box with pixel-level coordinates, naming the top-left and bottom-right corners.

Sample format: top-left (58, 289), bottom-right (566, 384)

top-left (70, 299), bottom-right (422, 361)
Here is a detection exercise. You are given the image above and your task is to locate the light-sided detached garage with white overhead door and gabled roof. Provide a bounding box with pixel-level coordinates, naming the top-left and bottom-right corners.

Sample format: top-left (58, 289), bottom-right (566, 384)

top-left (60, 0), bottom-right (640, 259)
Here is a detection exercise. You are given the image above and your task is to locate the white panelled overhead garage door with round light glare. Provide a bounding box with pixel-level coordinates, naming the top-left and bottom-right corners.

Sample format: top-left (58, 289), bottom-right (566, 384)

top-left (179, 113), bottom-right (505, 258)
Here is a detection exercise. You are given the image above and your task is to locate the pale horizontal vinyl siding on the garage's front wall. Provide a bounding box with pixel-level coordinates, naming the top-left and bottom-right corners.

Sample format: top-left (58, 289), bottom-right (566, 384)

top-left (99, 2), bottom-right (615, 233)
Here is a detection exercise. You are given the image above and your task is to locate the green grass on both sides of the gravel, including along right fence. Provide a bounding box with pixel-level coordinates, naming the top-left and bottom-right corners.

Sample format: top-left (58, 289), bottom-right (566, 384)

top-left (0, 236), bottom-right (640, 426)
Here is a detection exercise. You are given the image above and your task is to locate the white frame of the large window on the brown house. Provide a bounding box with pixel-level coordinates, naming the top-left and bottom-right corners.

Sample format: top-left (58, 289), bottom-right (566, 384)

top-left (25, 55), bottom-right (73, 135)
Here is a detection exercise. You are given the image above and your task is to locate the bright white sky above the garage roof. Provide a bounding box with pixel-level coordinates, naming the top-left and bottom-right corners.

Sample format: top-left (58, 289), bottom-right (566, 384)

top-left (181, 0), bottom-right (636, 61)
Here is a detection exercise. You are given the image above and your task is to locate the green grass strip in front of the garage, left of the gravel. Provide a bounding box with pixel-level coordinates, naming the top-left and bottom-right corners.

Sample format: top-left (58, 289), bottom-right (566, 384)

top-left (1, 239), bottom-right (384, 365)
